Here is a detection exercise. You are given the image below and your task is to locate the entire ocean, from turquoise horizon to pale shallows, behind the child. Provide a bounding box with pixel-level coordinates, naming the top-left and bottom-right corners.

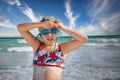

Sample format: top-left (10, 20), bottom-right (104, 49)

top-left (0, 35), bottom-right (120, 80)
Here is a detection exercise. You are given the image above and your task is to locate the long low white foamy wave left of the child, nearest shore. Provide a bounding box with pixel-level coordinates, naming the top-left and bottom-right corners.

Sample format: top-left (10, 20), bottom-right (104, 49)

top-left (8, 46), bottom-right (32, 52)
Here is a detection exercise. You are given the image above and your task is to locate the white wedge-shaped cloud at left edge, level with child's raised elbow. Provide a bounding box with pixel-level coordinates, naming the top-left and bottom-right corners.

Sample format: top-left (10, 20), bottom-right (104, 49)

top-left (0, 17), bottom-right (16, 28)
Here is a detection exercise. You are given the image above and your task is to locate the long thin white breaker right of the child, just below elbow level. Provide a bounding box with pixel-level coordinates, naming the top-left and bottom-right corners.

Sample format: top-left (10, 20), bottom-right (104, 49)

top-left (85, 43), bottom-right (120, 47)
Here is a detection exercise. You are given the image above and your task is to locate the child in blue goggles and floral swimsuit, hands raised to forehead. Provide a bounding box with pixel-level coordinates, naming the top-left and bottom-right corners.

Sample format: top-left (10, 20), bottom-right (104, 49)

top-left (17, 17), bottom-right (88, 80)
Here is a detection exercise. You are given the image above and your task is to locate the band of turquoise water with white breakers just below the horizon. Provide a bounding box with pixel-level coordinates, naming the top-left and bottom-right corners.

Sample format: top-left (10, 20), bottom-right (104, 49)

top-left (0, 35), bottom-right (120, 52)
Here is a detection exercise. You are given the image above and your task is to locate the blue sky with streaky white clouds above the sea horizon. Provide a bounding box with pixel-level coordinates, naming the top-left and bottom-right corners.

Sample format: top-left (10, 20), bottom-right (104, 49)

top-left (0, 0), bottom-right (120, 37)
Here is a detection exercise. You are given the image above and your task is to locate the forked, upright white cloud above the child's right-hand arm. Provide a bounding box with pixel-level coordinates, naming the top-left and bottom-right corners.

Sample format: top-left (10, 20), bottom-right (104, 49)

top-left (65, 1), bottom-right (79, 28)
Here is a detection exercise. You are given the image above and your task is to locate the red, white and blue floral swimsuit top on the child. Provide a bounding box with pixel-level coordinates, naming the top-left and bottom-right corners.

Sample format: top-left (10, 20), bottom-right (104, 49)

top-left (33, 44), bottom-right (64, 68)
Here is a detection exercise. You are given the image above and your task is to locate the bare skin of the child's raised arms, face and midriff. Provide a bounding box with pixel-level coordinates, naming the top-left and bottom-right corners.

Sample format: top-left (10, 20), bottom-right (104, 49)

top-left (17, 19), bottom-right (88, 80)
